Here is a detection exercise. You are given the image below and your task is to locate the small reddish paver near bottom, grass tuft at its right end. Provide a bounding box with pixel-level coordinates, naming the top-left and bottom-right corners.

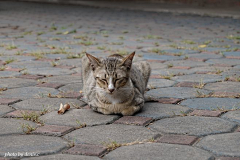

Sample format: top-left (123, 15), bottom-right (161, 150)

top-left (64, 144), bottom-right (107, 156)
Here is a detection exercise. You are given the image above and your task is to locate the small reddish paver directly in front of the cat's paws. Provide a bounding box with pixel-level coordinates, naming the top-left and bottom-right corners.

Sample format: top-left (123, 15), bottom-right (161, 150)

top-left (114, 116), bottom-right (152, 126)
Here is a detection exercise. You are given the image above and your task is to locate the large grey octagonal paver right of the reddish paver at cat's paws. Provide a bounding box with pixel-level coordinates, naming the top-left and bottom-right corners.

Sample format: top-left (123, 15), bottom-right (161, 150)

top-left (150, 116), bottom-right (236, 136)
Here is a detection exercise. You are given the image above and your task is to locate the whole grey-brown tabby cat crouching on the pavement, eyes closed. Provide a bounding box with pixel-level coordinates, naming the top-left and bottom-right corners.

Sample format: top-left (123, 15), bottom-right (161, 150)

top-left (82, 52), bottom-right (151, 115)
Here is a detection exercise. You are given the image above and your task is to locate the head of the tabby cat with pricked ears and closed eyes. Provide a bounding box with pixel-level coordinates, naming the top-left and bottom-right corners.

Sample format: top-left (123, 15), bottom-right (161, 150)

top-left (87, 52), bottom-right (135, 94)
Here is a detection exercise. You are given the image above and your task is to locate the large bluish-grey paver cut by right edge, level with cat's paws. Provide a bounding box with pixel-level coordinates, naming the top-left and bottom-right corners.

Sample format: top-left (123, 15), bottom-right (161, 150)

top-left (181, 98), bottom-right (240, 110)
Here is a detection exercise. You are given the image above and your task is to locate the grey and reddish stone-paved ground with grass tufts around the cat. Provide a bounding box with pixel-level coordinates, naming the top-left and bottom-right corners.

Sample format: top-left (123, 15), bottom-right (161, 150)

top-left (0, 2), bottom-right (240, 160)
